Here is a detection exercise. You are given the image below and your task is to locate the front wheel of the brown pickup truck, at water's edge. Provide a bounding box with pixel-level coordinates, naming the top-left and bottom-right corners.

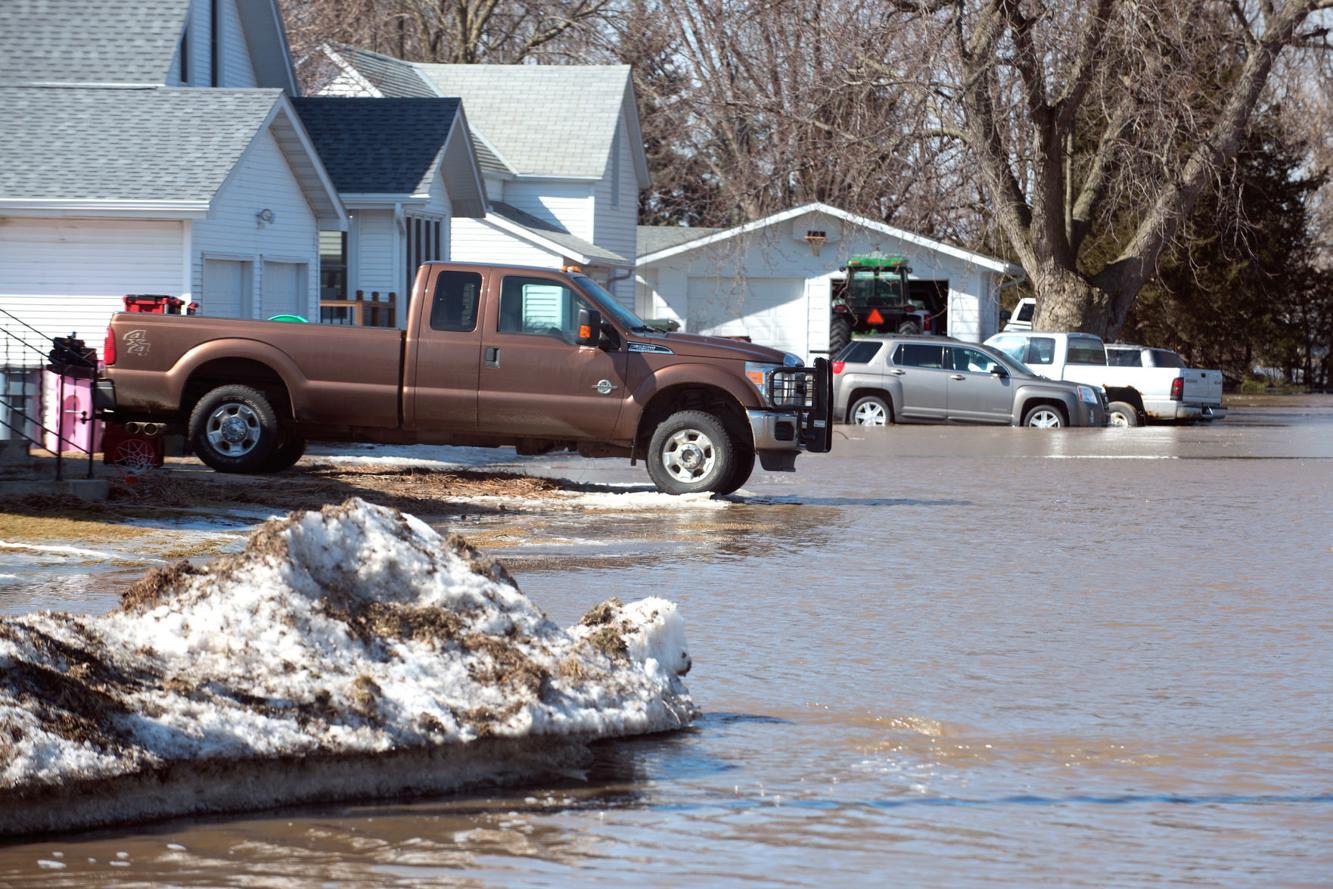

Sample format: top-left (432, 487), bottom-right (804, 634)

top-left (648, 411), bottom-right (740, 494)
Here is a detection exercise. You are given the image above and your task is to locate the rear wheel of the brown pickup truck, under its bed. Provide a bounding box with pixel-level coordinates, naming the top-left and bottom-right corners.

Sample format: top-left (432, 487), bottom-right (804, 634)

top-left (188, 385), bottom-right (279, 472)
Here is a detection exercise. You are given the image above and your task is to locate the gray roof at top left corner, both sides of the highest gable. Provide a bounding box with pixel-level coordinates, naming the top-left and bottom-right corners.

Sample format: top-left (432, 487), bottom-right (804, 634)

top-left (0, 0), bottom-right (299, 96)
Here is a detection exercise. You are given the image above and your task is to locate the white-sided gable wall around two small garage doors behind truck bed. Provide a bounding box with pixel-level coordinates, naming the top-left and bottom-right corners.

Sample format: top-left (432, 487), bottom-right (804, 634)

top-left (191, 131), bottom-right (319, 317)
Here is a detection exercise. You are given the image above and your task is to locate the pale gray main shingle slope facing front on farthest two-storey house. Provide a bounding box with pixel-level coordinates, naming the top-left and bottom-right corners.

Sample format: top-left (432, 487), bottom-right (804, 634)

top-left (416, 64), bottom-right (632, 179)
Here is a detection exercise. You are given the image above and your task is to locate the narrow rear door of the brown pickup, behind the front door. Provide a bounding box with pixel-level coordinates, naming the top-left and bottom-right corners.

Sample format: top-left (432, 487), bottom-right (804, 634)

top-left (410, 268), bottom-right (484, 432)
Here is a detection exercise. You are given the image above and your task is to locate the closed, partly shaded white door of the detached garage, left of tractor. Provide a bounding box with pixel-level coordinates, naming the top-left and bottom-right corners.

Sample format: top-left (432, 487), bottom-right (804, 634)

top-left (686, 277), bottom-right (808, 355)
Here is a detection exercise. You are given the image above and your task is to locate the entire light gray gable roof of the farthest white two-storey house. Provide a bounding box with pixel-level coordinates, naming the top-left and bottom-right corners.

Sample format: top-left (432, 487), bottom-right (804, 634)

top-left (325, 47), bottom-right (648, 188)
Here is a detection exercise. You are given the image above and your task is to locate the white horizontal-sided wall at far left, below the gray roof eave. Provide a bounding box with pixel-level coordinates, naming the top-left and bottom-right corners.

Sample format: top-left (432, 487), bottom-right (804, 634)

top-left (0, 217), bottom-right (189, 364)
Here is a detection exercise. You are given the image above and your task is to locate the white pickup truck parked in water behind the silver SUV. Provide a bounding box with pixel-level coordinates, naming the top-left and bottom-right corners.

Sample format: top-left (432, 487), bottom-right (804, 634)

top-left (986, 331), bottom-right (1226, 427)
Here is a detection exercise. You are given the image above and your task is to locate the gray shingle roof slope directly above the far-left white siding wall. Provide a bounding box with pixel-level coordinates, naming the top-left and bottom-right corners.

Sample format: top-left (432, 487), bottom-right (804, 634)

top-left (0, 87), bottom-right (283, 201)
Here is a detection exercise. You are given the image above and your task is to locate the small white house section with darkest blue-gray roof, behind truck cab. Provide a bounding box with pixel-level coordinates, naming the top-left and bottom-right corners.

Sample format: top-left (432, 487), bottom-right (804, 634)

top-left (295, 96), bottom-right (487, 319)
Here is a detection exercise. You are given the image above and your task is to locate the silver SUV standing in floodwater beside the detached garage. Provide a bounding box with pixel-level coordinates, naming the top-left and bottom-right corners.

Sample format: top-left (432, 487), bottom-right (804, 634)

top-left (833, 335), bottom-right (1106, 429)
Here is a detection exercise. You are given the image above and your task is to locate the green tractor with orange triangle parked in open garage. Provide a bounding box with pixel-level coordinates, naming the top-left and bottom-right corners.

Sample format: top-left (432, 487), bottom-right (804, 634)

top-left (829, 256), bottom-right (941, 355)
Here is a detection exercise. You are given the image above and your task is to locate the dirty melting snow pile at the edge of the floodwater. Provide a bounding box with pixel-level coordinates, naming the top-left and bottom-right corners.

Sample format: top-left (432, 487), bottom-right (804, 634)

top-left (0, 500), bottom-right (696, 833)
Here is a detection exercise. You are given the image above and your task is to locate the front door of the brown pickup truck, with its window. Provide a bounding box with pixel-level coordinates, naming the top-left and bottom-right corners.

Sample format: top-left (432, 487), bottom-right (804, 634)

top-left (479, 272), bottom-right (628, 440)
